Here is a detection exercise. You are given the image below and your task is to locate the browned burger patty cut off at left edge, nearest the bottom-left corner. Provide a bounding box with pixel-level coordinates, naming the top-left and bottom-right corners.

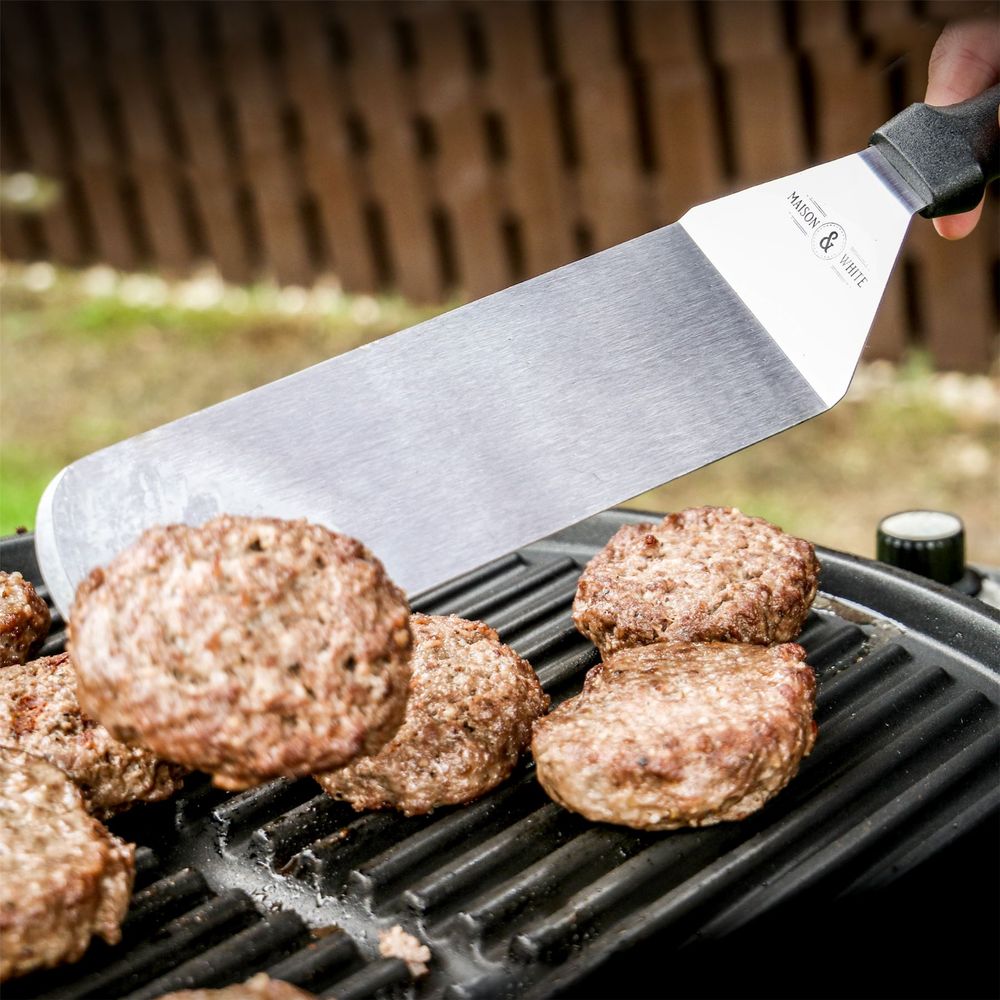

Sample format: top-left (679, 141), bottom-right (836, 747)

top-left (0, 747), bottom-right (135, 979)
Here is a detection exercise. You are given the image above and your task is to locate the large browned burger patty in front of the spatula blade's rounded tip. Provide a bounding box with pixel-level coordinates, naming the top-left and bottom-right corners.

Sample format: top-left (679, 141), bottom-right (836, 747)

top-left (69, 516), bottom-right (410, 789)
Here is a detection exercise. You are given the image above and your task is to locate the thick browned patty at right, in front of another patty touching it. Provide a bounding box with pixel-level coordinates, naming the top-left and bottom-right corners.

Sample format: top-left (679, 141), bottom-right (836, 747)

top-left (531, 642), bottom-right (816, 830)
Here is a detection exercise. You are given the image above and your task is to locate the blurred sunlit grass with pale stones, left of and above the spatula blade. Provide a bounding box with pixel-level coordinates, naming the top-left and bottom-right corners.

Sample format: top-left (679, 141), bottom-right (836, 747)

top-left (0, 266), bottom-right (439, 534)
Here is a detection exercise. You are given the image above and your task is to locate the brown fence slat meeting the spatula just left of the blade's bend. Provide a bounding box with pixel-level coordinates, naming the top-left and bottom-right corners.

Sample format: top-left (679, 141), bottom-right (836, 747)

top-left (554, 0), bottom-right (651, 250)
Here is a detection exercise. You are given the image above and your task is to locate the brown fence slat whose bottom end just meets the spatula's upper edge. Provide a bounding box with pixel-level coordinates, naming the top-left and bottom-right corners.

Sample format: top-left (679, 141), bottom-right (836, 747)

top-left (338, 4), bottom-right (445, 302)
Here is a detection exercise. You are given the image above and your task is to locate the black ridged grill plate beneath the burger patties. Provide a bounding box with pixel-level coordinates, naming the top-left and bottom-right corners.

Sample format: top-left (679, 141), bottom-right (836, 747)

top-left (0, 511), bottom-right (1000, 1000)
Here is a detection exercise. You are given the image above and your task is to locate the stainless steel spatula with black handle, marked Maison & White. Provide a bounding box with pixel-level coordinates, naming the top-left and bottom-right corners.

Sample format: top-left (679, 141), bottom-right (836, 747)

top-left (36, 87), bottom-right (1000, 613)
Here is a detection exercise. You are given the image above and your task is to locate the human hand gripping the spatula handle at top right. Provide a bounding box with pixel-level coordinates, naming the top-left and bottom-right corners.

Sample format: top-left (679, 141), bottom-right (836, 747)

top-left (924, 19), bottom-right (1000, 240)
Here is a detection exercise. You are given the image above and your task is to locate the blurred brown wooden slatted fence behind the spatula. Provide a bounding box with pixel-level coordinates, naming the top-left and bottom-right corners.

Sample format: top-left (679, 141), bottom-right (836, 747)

top-left (0, 0), bottom-right (998, 370)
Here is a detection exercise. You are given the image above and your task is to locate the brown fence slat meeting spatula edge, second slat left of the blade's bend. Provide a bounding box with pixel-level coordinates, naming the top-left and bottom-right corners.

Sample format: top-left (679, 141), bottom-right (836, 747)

top-left (477, 0), bottom-right (576, 277)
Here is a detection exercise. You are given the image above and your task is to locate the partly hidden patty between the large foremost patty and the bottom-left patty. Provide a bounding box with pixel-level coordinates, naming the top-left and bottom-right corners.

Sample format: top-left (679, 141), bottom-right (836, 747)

top-left (0, 653), bottom-right (184, 819)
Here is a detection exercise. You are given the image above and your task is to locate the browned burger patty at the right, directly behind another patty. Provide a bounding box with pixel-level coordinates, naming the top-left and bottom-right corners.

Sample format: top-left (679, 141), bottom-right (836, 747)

top-left (573, 507), bottom-right (819, 656)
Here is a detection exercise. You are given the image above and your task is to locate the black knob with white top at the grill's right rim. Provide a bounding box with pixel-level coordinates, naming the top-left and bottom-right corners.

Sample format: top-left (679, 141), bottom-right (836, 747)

top-left (876, 510), bottom-right (966, 589)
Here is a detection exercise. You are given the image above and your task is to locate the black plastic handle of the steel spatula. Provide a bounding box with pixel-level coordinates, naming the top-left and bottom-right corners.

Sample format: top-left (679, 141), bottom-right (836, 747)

top-left (869, 84), bottom-right (1000, 219)
